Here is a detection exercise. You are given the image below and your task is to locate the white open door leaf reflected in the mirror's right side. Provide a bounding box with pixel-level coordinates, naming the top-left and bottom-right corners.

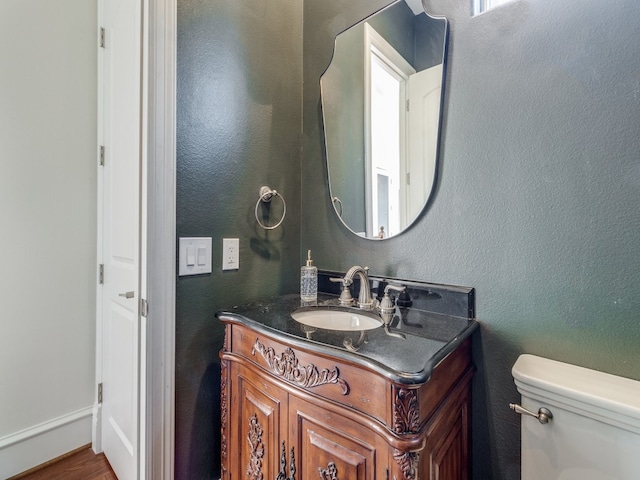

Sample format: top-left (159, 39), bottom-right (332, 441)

top-left (404, 64), bottom-right (442, 225)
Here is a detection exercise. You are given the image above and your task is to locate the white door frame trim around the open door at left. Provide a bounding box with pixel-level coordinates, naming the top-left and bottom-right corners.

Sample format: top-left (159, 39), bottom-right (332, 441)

top-left (92, 0), bottom-right (177, 480)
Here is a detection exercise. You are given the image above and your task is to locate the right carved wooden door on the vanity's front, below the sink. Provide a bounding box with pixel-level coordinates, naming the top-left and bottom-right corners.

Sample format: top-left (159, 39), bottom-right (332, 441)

top-left (289, 396), bottom-right (384, 480)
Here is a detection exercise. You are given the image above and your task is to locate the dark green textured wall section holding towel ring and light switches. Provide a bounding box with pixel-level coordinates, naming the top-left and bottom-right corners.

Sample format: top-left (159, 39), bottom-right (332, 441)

top-left (175, 0), bottom-right (302, 480)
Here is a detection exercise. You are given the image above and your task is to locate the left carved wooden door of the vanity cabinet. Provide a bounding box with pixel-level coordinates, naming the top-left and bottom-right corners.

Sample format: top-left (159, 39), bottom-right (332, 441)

top-left (229, 364), bottom-right (287, 480)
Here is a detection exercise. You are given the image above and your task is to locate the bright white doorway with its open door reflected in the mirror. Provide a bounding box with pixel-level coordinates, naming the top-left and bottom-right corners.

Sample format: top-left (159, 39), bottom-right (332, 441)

top-left (365, 24), bottom-right (442, 238)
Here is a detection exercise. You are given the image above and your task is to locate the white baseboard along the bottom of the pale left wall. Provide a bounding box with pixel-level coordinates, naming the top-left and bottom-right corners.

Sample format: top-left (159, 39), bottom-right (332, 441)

top-left (0, 407), bottom-right (92, 479)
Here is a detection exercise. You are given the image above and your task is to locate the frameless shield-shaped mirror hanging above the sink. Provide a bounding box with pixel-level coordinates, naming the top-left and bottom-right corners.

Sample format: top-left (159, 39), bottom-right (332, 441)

top-left (320, 0), bottom-right (448, 239)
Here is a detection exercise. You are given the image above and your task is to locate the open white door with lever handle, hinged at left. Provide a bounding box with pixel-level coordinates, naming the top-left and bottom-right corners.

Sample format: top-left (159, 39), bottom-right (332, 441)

top-left (98, 0), bottom-right (142, 480)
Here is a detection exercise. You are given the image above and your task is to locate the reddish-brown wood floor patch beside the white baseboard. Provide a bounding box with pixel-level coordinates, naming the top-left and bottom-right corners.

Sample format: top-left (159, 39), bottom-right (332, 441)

top-left (8, 446), bottom-right (118, 480)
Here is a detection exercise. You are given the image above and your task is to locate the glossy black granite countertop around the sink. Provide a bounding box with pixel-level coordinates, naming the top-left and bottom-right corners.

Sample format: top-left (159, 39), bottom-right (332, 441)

top-left (216, 293), bottom-right (477, 384)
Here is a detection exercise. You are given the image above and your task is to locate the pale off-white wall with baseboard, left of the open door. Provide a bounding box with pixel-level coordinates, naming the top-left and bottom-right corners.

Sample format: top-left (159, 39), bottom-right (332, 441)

top-left (0, 0), bottom-right (97, 478)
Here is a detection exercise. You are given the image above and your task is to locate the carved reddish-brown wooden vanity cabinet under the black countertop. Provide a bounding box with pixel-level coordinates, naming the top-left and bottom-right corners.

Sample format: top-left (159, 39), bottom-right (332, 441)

top-left (220, 323), bottom-right (473, 480)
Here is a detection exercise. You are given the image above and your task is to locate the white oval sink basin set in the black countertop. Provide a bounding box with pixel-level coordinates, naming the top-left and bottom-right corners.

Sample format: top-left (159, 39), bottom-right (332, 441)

top-left (291, 308), bottom-right (382, 331)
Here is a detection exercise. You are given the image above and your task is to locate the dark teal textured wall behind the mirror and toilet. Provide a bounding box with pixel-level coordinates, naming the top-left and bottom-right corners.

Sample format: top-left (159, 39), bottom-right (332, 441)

top-left (301, 0), bottom-right (640, 480)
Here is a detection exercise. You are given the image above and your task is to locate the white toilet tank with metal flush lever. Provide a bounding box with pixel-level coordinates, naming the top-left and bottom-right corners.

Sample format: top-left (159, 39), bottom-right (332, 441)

top-left (512, 355), bottom-right (640, 480)
